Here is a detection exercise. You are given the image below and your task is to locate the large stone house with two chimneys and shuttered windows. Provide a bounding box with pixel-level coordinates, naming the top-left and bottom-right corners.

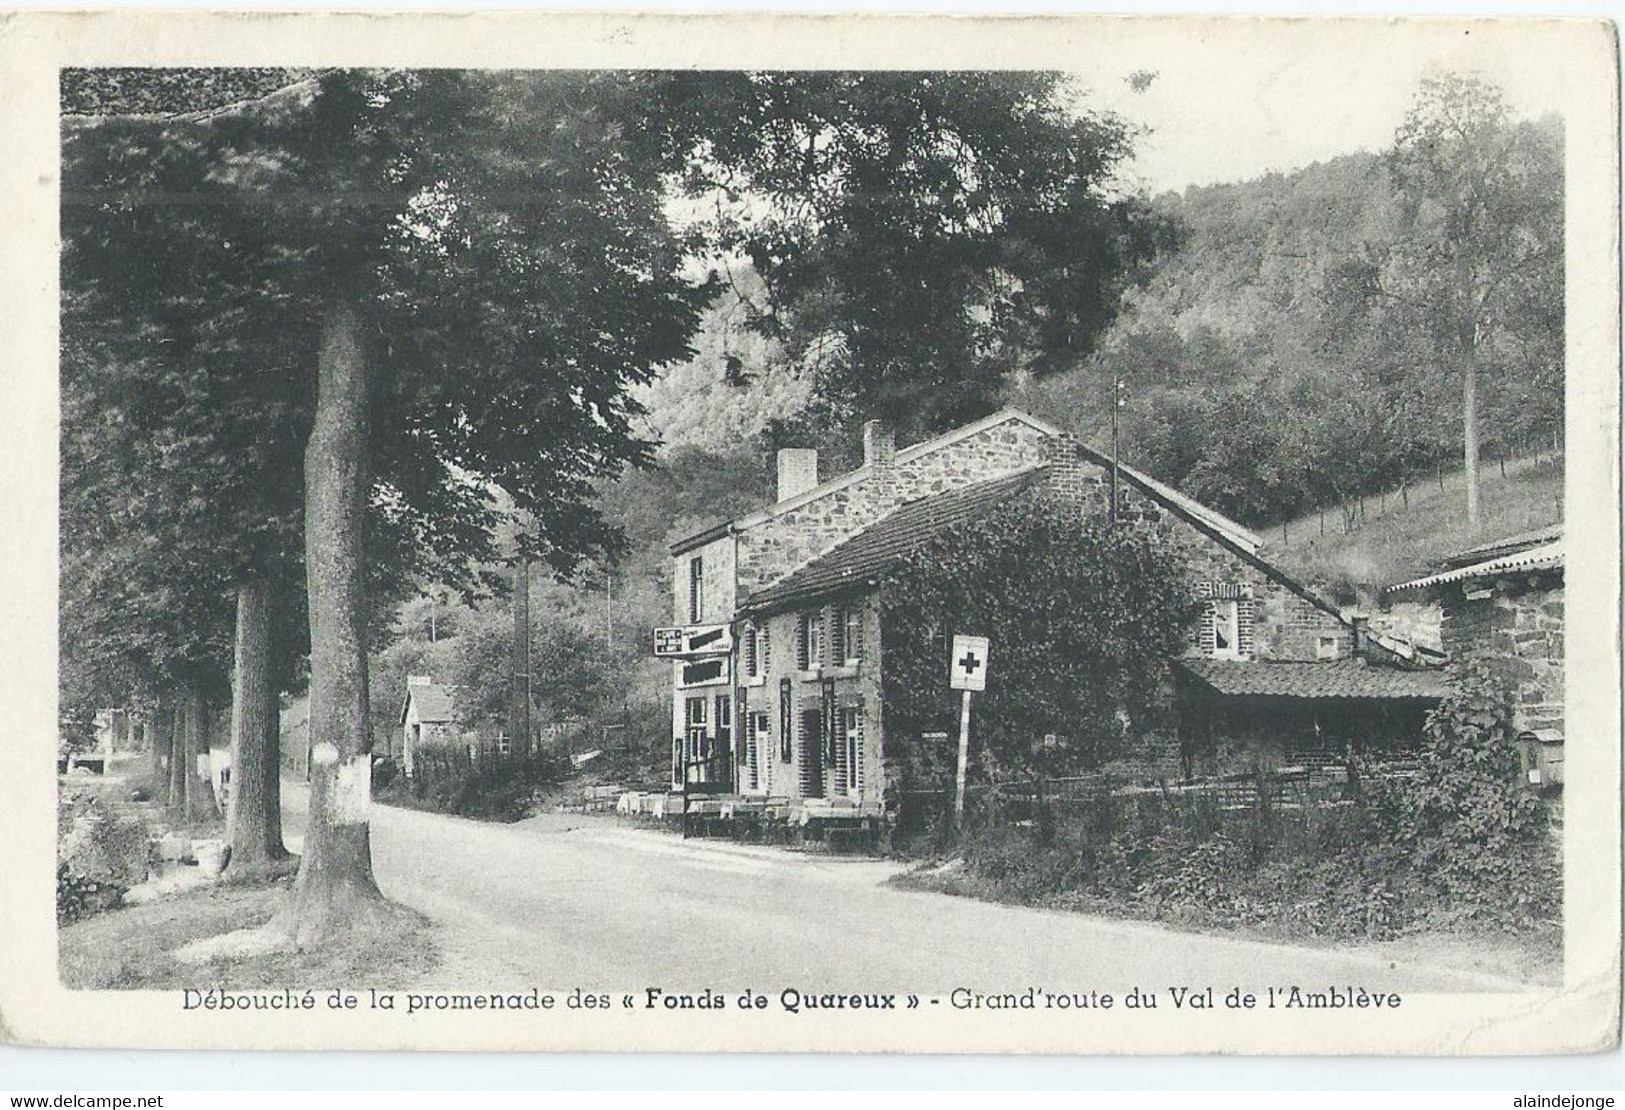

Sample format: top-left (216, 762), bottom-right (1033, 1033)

top-left (671, 410), bottom-right (1443, 813)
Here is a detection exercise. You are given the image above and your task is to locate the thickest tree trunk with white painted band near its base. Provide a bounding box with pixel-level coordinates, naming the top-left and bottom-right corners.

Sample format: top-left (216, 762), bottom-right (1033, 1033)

top-left (273, 299), bottom-right (385, 944)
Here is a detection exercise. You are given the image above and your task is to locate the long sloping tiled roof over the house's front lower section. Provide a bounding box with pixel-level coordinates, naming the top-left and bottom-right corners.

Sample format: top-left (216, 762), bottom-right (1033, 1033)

top-left (741, 465), bottom-right (1048, 613)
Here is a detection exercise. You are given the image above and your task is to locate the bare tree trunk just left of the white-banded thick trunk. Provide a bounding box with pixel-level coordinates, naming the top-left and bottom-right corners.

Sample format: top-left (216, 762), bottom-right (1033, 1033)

top-left (226, 579), bottom-right (288, 879)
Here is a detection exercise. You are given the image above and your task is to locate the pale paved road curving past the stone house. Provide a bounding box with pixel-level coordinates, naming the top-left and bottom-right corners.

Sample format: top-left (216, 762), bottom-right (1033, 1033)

top-left (284, 783), bottom-right (1518, 995)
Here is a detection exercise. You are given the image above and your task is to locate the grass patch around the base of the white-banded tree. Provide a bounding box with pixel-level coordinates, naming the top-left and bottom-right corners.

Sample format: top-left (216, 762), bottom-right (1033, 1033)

top-left (57, 879), bottom-right (439, 990)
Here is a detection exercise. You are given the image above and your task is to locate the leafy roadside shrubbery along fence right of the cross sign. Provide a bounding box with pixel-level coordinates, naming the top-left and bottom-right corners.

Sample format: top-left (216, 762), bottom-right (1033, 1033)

top-left (923, 671), bottom-right (1562, 939)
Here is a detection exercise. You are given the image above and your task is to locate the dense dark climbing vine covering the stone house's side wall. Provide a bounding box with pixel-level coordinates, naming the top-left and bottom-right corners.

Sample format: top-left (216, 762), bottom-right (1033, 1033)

top-left (879, 496), bottom-right (1196, 788)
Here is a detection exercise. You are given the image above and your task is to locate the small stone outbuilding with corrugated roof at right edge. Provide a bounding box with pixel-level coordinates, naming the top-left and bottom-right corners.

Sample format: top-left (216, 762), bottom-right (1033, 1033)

top-left (1383, 525), bottom-right (1563, 785)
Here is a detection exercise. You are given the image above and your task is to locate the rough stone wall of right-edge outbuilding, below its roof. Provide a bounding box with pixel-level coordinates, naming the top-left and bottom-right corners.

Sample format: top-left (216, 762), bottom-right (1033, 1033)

top-left (1441, 574), bottom-right (1563, 731)
